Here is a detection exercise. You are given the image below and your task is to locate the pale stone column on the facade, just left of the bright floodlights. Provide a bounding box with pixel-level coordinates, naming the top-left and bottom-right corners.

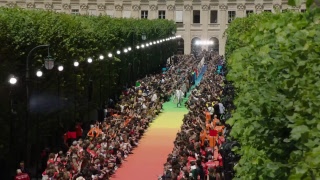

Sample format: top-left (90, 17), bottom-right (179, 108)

top-left (183, 4), bottom-right (192, 54)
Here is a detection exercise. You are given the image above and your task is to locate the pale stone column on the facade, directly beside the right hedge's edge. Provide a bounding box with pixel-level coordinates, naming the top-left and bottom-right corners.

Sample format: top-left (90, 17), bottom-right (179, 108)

top-left (218, 4), bottom-right (228, 55)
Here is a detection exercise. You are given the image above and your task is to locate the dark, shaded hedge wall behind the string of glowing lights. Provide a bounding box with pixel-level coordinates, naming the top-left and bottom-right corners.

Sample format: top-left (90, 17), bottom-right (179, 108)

top-left (0, 8), bottom-right (177, 171)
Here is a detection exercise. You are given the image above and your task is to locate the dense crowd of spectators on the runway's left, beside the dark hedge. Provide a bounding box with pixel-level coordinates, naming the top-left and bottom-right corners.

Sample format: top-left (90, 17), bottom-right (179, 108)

top-left (31, 55), bottom-right (205, 180)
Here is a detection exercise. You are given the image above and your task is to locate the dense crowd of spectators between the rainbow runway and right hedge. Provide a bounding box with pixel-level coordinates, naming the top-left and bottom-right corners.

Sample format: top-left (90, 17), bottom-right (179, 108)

top-left (160, 54), bottom-right (227, 180)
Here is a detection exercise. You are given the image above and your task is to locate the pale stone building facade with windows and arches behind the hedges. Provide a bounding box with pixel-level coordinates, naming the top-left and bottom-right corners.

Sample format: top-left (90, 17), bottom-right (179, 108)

top-left (0, 0), bottom-right (306, 54)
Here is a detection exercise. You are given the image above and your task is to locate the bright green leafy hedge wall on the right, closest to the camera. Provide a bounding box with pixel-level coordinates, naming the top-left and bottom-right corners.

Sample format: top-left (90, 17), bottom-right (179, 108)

top-left (226, 9), bottom-right (320, 179)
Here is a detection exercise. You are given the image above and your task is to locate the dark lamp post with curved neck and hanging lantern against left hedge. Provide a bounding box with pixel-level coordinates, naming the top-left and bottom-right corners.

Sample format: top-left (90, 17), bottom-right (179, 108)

top-left (25, 44), bottom-right (54, 166)
